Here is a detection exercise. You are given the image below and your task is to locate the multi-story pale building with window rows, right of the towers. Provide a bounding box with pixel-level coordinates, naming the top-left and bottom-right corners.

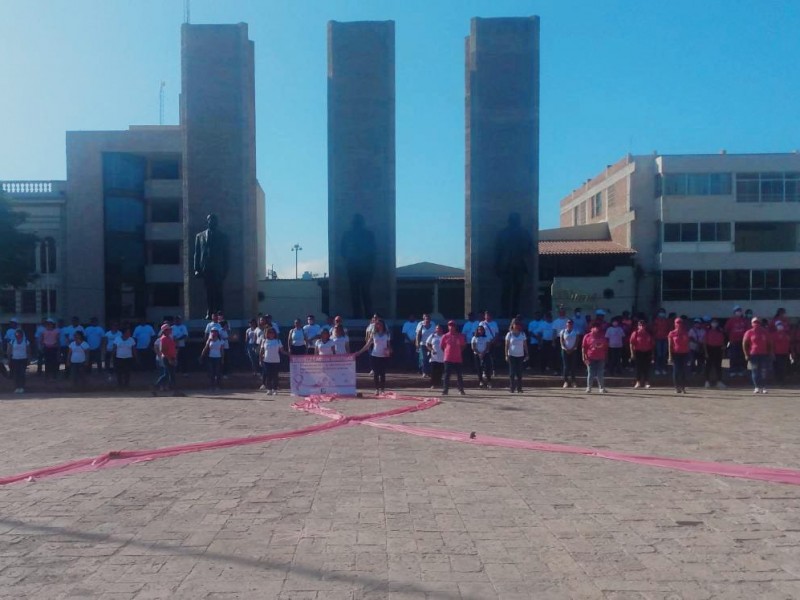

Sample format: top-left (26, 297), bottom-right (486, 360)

top-left (560, 152), bottom-right (800, 316)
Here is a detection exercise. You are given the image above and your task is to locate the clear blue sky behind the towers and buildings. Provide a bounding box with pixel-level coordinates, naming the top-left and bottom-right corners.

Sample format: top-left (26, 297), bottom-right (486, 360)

top-left (0, 0), bottom-right (800, 277)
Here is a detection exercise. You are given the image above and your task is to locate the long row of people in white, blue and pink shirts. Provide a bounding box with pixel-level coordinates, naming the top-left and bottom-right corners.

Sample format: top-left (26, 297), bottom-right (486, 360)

top-left (0, 306), bottom-right (800, 395)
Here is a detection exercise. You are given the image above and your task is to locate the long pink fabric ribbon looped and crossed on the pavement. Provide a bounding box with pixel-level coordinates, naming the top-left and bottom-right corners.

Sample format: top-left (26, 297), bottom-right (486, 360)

top-left (0, 392), bottom-right (800, 485)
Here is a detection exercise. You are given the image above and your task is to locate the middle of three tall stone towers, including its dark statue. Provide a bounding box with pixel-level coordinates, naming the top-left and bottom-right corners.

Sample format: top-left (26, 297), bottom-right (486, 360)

top-left (328, 21), bottom-right (396, 318)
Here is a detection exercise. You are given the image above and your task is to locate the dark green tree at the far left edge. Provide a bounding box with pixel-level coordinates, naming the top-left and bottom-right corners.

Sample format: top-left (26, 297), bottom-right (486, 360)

top-left (0, 190), bottom-right (37, 288)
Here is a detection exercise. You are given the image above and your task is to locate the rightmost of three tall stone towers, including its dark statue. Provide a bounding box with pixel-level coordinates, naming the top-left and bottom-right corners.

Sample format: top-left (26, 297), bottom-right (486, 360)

top-left (465, 17), bottom-right (539, 318)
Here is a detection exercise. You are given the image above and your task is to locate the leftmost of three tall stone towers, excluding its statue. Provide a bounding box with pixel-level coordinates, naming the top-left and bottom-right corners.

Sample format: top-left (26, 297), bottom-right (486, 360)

top-left (181, 23), bottom-right (256, 319)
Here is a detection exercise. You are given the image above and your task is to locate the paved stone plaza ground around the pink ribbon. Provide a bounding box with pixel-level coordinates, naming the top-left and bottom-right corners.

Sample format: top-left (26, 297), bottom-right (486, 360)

top-left (0, 388), bottom-right (800, 600)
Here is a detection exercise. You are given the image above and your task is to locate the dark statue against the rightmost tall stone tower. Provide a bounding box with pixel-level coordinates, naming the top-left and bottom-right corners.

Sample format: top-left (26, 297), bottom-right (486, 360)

top-left (494, 212), bottom-right (533, 317)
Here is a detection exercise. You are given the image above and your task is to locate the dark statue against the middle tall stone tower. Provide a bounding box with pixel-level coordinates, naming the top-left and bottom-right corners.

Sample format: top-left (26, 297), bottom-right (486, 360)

top-left (340, 214), bottom-right (375, 319)
